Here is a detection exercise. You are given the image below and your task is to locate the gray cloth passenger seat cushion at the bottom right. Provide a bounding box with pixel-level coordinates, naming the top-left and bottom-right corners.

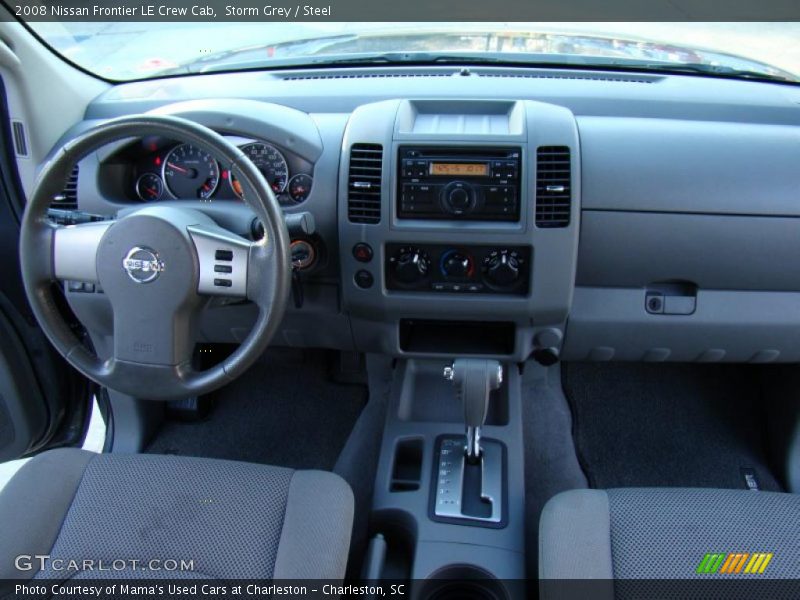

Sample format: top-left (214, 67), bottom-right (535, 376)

top-left (539, 488), bottom-right (800, 597)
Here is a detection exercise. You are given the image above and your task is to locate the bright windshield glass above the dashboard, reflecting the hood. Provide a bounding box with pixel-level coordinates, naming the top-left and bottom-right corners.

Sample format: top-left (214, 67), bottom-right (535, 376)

top-left (28, 22), bottom-right (800, 82)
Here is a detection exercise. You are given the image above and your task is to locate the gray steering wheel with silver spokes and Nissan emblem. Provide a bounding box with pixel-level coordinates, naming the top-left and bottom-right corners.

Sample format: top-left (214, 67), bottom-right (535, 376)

top-left (20, 115), bottom-right (291, 400)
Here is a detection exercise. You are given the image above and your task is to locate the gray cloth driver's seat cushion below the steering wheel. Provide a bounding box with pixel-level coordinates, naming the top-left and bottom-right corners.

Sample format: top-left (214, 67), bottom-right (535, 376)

top-left (0, 449), bottom-right (353, 579)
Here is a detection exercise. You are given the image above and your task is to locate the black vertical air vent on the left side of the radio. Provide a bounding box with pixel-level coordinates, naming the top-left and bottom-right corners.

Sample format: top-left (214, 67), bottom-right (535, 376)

top-left (347, 144), bottom-right (383, 224)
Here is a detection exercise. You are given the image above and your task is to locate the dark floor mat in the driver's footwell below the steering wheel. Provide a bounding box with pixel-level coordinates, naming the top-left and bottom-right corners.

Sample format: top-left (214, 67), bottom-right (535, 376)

top-left (147, 349), bottom-right (367, 470)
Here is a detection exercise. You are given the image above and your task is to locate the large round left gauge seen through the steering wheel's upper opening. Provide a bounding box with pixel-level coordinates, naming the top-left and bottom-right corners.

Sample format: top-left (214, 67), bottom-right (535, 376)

top-left (162, 144), bottom-right (219, 199)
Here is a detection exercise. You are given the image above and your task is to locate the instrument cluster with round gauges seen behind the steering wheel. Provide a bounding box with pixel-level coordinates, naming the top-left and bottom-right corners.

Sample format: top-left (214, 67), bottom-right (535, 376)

top-left (129, 137), bottom-right (314, 206)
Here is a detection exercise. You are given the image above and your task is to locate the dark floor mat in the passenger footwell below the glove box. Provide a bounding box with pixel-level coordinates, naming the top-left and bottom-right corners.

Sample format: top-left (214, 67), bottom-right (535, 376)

top-left (562, 363), bottom-right (782, 491)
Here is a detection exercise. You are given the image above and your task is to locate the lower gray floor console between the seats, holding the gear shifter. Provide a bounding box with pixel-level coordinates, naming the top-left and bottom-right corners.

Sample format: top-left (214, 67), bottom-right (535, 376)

top-left (362, 358), bottom-right (526, 599)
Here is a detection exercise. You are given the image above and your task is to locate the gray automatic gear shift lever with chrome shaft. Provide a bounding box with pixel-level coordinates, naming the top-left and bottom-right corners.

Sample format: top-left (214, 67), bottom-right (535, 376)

top-left (444, 358), bottom-right (503, 461)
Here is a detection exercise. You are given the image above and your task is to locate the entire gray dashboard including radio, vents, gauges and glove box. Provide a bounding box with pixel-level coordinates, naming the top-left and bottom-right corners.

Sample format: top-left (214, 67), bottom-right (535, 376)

top-left (47, 66), bottom-right (800, 362)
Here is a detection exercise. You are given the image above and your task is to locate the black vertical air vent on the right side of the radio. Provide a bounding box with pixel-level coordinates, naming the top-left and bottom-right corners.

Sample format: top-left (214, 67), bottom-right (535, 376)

top-left (536, 146), bottom-right (572, 227)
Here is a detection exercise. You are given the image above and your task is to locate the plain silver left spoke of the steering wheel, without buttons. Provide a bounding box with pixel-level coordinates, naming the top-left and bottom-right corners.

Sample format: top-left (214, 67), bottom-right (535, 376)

top-left (52, 221), bottom-right (112, 283)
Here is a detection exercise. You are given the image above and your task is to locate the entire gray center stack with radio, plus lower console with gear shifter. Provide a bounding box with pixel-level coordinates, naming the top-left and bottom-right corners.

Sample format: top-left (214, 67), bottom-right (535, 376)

top-left (338, 99), bottom-right (580, 598)
